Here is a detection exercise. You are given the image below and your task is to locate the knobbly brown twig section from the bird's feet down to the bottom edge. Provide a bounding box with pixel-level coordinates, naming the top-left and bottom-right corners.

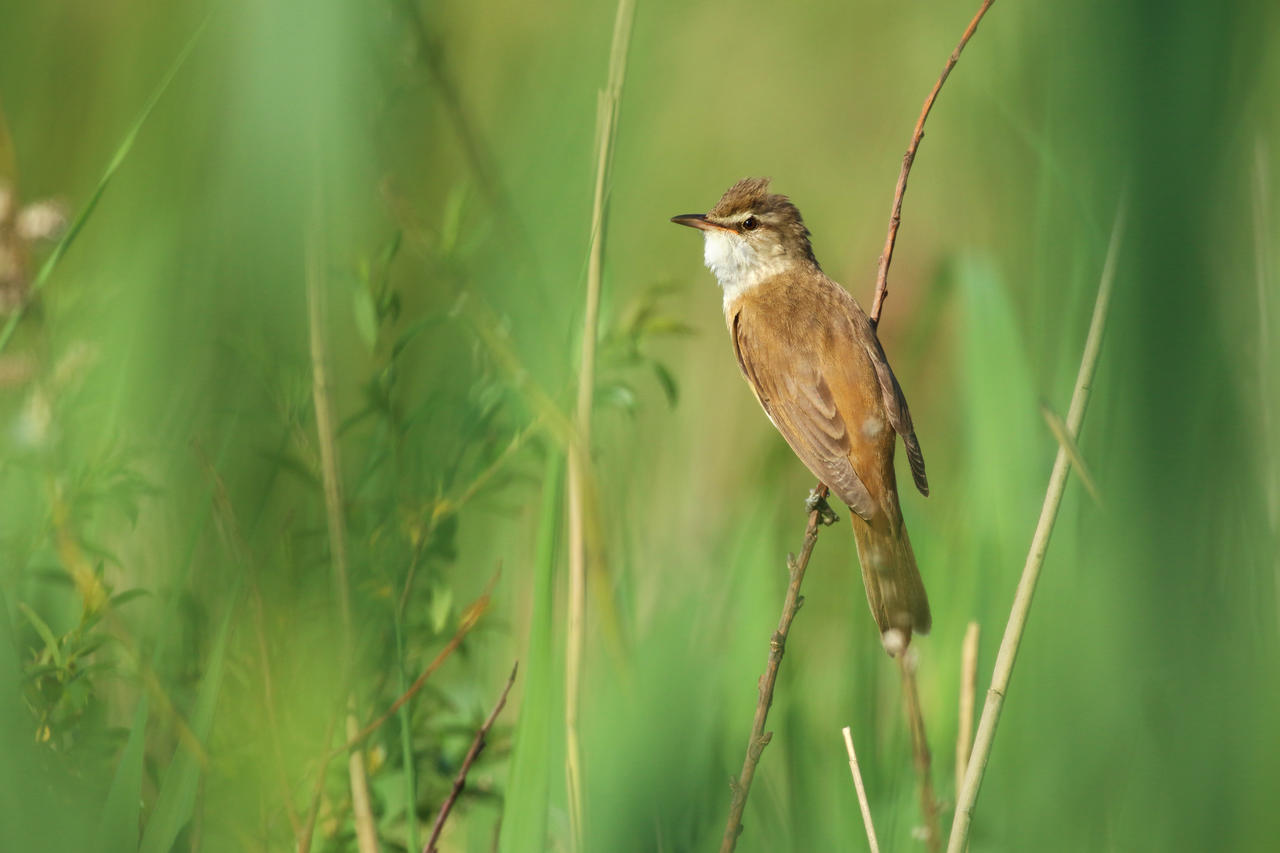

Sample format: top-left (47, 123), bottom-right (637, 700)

top-left (721, 484), bottom-right (835, 853)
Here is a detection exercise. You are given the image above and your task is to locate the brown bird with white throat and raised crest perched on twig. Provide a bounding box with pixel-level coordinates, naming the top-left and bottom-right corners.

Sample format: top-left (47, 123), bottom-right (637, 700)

top-left (671, 178), bottom-right (933, 654)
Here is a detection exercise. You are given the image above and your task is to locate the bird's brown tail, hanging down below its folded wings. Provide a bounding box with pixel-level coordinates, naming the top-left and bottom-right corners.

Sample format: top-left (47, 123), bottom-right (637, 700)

top-left (850, 514), bottom-right (933, 656)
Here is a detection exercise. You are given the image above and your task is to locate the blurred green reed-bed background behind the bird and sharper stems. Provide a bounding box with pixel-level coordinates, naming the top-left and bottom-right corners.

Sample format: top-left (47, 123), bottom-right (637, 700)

top-left (0, 0), bottom-right (1280, 852)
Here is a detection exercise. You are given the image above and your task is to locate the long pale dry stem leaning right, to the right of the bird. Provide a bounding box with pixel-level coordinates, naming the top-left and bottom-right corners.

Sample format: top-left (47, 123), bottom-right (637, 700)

top-left (947, 201), bottom-right (1124, 853)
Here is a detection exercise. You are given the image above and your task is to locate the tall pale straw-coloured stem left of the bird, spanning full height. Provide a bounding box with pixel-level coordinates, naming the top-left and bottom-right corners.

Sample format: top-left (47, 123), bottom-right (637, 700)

top-left (564, 0), bottom-right (635, 850)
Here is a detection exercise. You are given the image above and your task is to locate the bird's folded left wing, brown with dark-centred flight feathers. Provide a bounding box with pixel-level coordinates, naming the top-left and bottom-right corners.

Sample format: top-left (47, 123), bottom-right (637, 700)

top-left (732, 307), bottom-right (880, 521)
